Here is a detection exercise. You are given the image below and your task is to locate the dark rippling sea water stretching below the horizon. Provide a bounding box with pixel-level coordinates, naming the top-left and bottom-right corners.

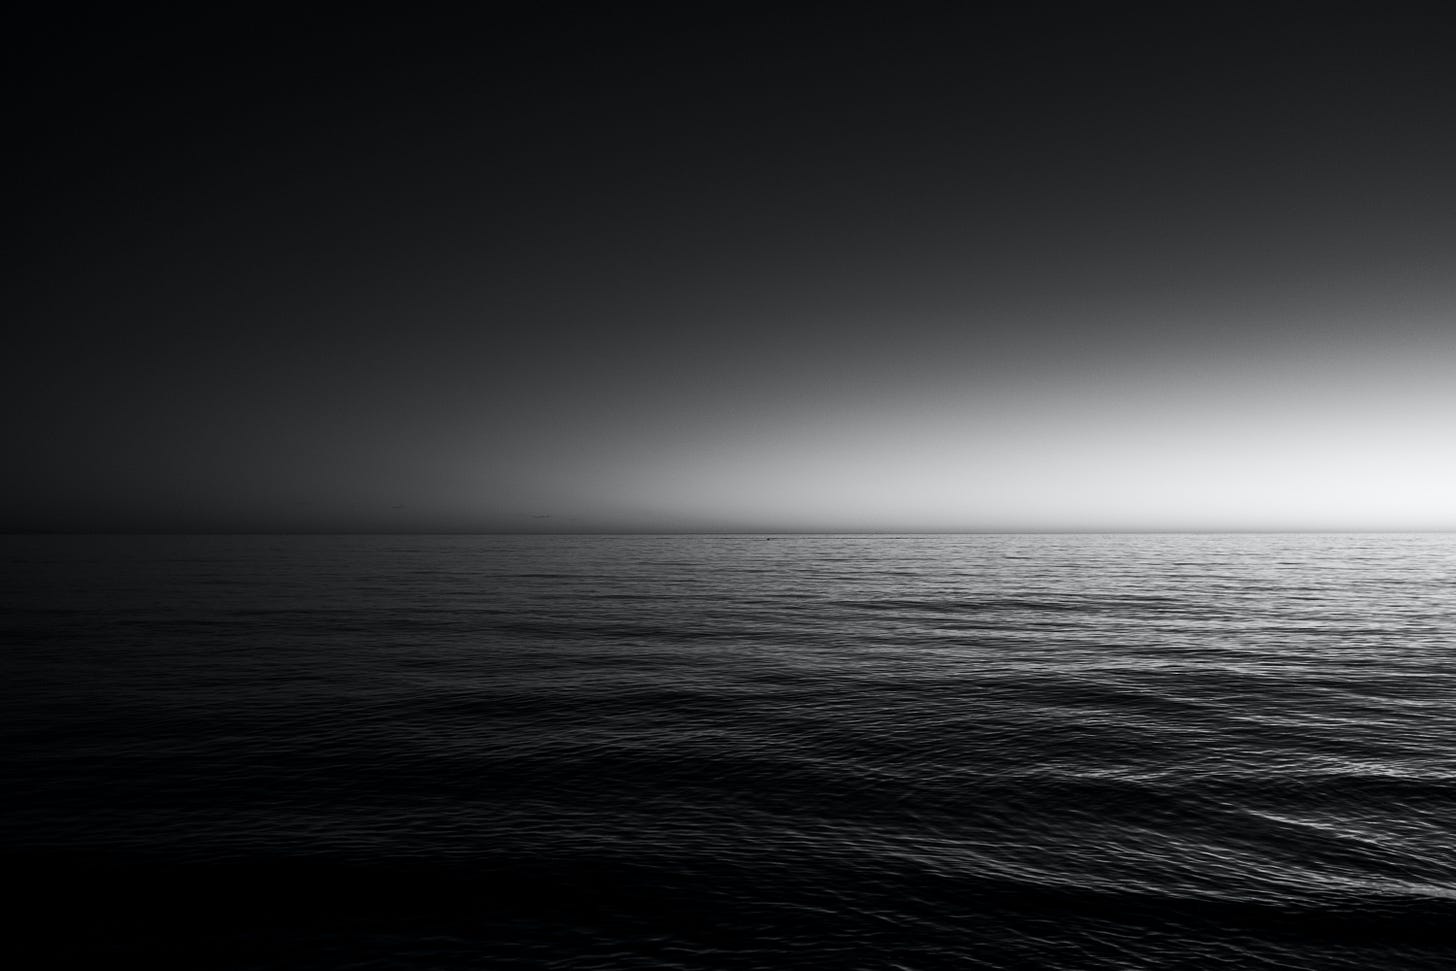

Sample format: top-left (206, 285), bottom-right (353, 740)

top-left (0, 536), bottom-right (1456, 971)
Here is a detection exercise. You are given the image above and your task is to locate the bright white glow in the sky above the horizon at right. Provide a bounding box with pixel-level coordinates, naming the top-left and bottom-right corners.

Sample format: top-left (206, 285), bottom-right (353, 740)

top-left (570, 334), bottom-right (1456, 531)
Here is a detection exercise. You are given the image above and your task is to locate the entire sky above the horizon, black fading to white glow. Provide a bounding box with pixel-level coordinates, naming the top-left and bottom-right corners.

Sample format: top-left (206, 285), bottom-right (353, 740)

top-left (11, 3), bottom-right (1456, 531)
